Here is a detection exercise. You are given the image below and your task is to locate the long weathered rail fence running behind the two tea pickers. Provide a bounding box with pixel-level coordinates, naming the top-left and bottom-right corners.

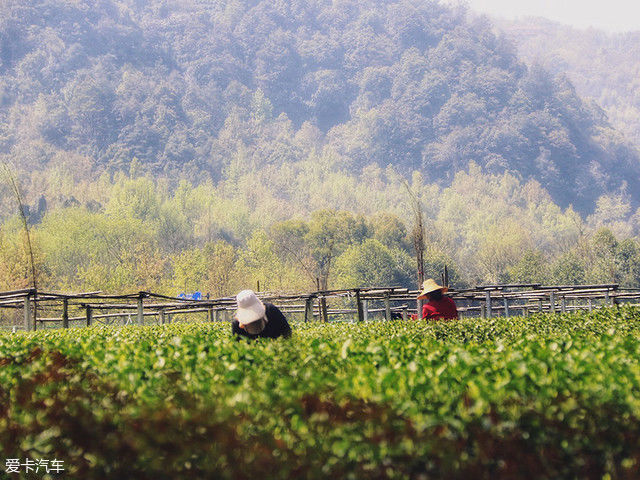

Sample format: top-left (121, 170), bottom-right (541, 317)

top-left (0, 284), bottom-right (640, 330)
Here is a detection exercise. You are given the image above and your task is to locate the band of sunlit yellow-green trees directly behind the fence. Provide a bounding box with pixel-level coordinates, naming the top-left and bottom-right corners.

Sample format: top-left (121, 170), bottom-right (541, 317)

top-left (0, 163), bottom-right (640, 296)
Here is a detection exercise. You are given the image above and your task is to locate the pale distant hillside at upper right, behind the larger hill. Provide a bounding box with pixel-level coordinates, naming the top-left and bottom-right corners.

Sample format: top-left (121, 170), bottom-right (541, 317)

top-left (496, 18), bottom-right (640, 146)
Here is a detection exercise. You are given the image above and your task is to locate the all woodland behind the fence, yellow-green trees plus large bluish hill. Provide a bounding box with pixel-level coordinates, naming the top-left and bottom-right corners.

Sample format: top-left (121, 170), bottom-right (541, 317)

top-left (0, 0), bottom-right (640, 295)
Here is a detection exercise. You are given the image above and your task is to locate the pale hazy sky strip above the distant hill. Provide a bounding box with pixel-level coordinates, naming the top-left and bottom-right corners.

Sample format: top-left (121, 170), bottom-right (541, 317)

top-left (443, 0), bottom-right (640, 32)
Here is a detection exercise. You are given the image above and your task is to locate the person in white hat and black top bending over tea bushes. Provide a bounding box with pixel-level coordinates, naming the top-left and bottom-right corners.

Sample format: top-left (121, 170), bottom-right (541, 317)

top-left (231, 290), bottom-right (291, 339)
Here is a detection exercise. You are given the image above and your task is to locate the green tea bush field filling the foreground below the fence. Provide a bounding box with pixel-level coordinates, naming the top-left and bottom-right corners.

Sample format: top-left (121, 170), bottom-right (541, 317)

top-left (0, 308), bottom-right (640, 480)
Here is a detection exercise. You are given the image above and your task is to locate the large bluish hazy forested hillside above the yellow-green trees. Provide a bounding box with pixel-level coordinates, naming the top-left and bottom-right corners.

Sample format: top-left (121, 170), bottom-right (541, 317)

top-left (0, 0), bottom-right (640, 212)
